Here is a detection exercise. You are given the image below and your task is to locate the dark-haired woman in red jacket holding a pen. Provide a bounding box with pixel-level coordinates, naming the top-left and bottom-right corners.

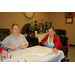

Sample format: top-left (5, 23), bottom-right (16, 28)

top-left (41, 27), bottom-right (62, 53)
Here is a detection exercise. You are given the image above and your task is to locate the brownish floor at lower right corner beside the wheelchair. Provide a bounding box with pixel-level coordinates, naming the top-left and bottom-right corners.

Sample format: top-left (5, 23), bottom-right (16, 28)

top-left (67, 46), bottom-right (75, 62)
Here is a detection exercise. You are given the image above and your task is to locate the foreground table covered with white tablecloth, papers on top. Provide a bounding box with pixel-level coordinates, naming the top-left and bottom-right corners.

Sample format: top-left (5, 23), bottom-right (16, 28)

top-left (0, 46), bottom-right (64, 62)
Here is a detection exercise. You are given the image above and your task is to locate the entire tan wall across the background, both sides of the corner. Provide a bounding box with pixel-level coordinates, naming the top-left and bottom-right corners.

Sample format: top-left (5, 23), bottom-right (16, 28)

top-left (0, 12), bottom-right (75, 45)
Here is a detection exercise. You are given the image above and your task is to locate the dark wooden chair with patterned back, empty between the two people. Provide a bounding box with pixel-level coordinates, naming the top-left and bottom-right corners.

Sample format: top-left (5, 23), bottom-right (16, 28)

top-left (26, 30), bottom-right (39, 47)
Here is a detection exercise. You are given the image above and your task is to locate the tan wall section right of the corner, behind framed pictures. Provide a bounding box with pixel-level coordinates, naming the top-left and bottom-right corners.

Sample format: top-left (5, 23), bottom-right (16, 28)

top-left (50, 12), bottom-right (75, 45)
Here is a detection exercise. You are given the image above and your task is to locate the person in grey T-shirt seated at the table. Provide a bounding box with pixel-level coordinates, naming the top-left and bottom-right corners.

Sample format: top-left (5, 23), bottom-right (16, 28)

top-left (2, 23), bottom-right (29, 52)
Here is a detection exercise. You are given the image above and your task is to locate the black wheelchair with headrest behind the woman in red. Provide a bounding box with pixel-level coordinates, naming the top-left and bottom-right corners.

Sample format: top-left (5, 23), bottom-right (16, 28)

top-left (59, 30), bottom-right (69, 62)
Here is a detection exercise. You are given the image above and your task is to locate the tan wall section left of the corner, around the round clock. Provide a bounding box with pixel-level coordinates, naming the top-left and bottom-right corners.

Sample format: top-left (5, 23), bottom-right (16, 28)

top-left (0, 12), bottom-right (50, 31)
